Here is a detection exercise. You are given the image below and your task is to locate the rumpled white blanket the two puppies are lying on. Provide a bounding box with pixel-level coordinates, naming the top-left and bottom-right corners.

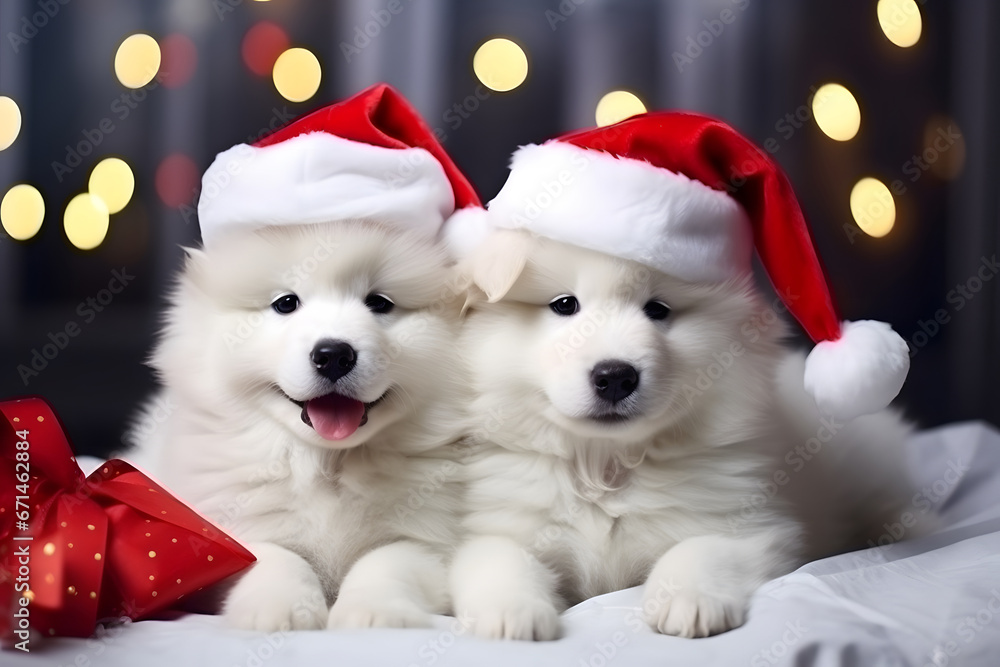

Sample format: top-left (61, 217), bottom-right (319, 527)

top-left (7, 423), bottom-right (1000, 667)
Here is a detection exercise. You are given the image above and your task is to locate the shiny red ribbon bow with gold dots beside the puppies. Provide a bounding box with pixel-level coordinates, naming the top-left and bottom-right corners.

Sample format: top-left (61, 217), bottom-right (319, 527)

top-left (0, 398), bottom-right (256, 642)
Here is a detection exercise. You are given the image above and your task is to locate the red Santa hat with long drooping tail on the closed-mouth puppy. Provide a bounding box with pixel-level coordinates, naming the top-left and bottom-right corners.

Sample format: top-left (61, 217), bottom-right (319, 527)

top-left (447, 112), bottom-right (909, 419)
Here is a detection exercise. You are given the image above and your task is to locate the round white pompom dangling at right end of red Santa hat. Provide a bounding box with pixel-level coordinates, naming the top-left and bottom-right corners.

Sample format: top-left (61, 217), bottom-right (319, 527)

top-left (805, 320), bottom-right (910, 420)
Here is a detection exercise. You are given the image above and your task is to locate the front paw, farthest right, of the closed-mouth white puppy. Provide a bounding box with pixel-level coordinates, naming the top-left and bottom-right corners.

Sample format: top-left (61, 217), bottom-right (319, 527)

top-left (642, 582), bottom-right (747, 638)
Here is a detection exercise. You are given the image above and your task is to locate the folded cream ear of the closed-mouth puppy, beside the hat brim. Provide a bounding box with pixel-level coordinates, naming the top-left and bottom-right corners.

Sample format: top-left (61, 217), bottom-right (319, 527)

top-left (459, 230), bottom-right (531, 308)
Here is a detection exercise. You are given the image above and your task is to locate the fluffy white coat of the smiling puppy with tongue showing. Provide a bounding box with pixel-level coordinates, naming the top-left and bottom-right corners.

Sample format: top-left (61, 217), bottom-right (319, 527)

top-left (127, 221), bottom-right (467, 631)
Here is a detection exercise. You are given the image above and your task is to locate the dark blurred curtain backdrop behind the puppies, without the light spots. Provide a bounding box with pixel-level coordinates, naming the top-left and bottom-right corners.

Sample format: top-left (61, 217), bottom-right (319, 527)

top-left (0, 0), bottom-right (1000, 454)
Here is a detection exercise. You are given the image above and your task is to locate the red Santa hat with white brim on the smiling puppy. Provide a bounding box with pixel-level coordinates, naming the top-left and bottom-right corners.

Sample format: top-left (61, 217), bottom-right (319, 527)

top-left (198, 84), bottom-right (481, 249)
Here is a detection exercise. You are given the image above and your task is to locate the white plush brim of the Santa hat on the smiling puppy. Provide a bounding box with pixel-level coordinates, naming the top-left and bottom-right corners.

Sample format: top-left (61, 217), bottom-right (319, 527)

top-left (198, 132), bottom-right (455, 248)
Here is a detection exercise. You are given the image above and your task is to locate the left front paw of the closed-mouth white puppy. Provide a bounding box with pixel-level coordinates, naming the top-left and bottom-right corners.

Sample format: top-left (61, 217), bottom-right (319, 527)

top-left (458, 599), bottom-right (559, 641)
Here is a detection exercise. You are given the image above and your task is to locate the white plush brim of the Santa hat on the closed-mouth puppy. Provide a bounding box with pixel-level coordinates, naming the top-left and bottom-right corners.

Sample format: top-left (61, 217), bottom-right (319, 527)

top-left (489, 141), bottom-right (753, 282)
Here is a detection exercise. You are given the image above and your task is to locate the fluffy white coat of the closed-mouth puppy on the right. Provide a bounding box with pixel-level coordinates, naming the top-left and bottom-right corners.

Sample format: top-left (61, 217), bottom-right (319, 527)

top-left (451, 231), bottom-right (908, 639)
